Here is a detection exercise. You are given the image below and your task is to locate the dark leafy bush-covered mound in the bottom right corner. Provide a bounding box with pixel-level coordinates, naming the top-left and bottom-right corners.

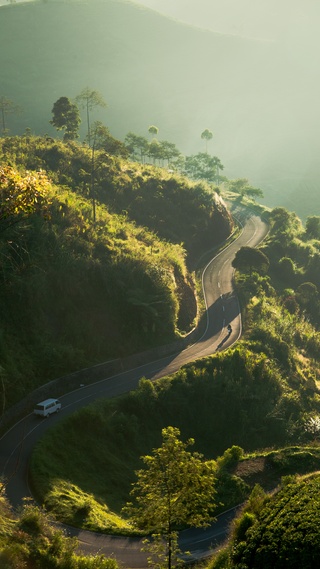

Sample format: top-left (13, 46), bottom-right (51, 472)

top-left (231, 477), bottom-right (320, 569)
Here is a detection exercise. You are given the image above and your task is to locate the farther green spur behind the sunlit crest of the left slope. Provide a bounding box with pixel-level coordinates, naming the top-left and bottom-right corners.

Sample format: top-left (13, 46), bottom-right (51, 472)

top-left (0, 135), bottom-right (233, 253)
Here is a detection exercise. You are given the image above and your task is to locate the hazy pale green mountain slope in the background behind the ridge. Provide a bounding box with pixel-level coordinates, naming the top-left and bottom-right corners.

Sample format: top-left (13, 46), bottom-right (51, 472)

top-left (0, 0), bottom-right (319, 219)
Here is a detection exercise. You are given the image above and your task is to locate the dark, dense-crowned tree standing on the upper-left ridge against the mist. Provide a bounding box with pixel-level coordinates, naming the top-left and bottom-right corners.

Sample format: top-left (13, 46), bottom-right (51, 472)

top-left (50, 97), bottom-right (81, 140)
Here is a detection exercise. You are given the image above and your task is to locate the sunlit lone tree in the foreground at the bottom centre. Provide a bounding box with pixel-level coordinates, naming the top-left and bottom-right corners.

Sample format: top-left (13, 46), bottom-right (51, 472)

top-left (125, 427), bottom-right (215, 569)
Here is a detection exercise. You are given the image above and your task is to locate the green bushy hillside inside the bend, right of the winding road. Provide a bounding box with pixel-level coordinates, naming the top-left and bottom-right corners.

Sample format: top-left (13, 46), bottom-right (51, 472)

top-left (25, 199), bottom-right (320, 540)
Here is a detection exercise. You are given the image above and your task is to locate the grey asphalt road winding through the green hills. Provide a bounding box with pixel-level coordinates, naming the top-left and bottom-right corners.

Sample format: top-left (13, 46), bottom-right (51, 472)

top-left (0, 211), bottom-right (268, 569)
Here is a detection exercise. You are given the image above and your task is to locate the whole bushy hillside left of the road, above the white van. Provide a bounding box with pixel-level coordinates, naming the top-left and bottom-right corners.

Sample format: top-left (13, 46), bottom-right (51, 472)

top-left (0, 136), bottom-right (231, 408)
